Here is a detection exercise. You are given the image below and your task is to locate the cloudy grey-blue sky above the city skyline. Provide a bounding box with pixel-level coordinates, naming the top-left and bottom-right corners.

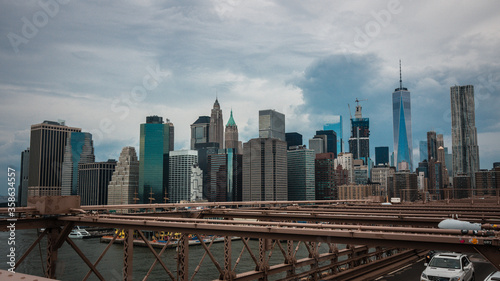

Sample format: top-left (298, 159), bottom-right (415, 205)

top-left (0, 0), bottom-right (500, 194)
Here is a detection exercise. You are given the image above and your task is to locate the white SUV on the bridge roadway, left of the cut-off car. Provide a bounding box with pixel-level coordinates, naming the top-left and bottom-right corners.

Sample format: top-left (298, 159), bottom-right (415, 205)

top-left (420, 253), bottom-right (475, 281)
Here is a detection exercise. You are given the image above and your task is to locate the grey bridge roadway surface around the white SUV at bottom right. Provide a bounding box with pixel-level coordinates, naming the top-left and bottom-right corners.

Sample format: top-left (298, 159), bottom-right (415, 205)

top-left (377, 253), bottom-right (495, 281)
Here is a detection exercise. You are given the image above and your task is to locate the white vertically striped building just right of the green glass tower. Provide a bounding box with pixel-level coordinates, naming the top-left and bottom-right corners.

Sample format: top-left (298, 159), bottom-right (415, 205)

top-left (167, 150), bottom-right (199, 203)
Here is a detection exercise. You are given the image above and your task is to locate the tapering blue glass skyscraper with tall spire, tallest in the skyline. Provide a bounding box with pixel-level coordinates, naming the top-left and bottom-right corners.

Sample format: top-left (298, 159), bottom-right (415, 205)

top-left (392, 61), bottom-right (413, 171)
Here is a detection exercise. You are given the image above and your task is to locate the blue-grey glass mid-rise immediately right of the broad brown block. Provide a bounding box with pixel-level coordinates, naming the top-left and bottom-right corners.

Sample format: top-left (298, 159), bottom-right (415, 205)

top-left (287, 146), bottom-right (316, 201)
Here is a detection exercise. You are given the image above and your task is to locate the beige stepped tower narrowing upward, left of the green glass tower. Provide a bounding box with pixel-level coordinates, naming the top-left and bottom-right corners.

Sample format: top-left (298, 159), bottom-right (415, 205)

top-left (108, 146), bottom-right (139, 208)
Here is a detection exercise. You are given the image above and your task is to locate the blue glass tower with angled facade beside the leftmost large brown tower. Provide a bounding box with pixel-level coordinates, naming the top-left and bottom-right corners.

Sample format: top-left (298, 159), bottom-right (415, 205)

top-left (61, 132), bottom-right (95, 195)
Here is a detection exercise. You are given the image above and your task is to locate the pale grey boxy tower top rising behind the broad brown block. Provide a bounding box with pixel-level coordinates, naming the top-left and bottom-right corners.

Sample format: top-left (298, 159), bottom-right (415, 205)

top-left (259, 109), bottom-right (286, 141)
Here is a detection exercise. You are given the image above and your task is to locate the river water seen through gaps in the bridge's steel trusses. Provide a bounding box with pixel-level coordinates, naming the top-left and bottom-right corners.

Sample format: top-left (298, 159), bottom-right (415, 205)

top-left (0, 229), bottom-right (346, 281)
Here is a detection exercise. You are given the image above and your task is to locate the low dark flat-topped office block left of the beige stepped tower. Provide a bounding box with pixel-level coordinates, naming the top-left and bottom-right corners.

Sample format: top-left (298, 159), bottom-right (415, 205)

top-left (78, 159), bottom-right (116, 205)
